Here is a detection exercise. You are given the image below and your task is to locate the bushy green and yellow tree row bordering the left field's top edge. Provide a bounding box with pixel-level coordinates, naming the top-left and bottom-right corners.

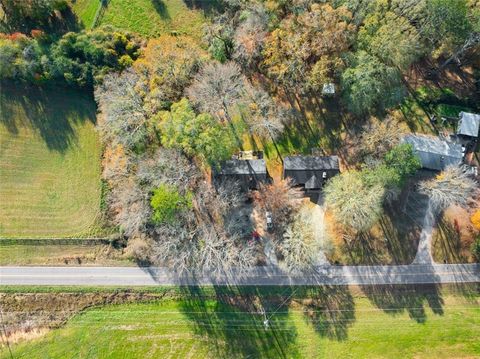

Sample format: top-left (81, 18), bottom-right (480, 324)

top-left (0, 27), bottom-right (140, 88)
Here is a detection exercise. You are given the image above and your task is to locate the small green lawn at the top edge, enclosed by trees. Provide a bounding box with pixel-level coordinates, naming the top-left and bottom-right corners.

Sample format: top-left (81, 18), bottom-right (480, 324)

top-left (100, 0), bottom-right (206, 38)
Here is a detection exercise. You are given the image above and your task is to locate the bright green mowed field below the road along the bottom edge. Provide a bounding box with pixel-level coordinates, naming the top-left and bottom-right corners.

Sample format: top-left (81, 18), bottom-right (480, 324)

top-left (6, 295), bottom-right (480, 359)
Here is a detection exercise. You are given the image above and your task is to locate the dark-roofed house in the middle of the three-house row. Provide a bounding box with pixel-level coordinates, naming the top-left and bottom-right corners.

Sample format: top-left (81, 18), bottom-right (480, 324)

top-left (283, 156), bottom-right (340, 190)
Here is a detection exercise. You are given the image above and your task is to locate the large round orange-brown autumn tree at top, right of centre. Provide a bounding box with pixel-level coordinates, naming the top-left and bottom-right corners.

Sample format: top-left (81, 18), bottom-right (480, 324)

top-left (263, 4), bottom-right (354, 91)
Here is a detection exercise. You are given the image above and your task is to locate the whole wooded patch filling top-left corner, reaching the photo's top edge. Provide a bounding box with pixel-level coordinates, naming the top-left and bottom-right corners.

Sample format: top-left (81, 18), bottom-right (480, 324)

top-left (0, 0), bottom-right (140, 89)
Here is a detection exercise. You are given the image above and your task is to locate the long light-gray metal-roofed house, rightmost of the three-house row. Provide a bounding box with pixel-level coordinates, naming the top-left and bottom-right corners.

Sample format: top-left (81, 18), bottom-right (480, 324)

top-left (403, 135), bottom-right (463, 171)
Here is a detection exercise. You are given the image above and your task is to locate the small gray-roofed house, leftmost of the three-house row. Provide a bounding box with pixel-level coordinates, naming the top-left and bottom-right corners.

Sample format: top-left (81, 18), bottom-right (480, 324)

top-left (214, 159), bottom-right (269, 189)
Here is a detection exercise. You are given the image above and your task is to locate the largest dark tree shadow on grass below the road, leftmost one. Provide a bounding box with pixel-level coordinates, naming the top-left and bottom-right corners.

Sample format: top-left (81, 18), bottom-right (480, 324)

top-left (181, 286), bottom-right (297, 358)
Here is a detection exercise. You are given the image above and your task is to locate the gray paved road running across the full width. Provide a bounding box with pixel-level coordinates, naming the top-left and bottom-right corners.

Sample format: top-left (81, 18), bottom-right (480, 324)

top-left (0, 264), bottom-right (480, 286)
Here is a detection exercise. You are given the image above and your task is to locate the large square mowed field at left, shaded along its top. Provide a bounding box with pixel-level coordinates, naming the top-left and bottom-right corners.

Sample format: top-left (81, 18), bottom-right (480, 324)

top-left (0, 83), bottom-right (101, 238)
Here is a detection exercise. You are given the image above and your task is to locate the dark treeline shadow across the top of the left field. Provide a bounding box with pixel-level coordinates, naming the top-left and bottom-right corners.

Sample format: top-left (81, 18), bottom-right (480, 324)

top-left (0, 82), bottom-right (96, 153)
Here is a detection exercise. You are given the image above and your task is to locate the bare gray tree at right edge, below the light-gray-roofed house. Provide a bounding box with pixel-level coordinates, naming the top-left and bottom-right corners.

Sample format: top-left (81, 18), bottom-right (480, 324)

top-left (420, 166), bottom-right (478, 212)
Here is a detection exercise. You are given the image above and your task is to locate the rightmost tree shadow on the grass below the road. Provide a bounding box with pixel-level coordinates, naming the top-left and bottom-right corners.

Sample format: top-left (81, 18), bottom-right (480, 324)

top-left (361, 284), bottom-right (444, 323)
